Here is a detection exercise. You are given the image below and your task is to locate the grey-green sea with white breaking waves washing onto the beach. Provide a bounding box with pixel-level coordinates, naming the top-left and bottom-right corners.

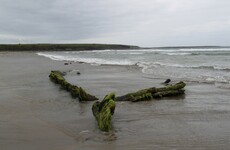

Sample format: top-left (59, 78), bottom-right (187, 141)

top-left (37, 47), bottom-right (230, 88)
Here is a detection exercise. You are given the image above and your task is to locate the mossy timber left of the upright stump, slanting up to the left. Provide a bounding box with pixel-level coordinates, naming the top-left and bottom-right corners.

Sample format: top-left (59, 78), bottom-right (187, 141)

top-left (49, 71), bottom-right (98, 101)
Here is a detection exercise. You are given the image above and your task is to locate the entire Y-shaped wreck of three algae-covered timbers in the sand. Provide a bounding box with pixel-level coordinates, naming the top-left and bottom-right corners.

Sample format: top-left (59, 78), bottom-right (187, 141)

top-left (49, 71), bottom-right (186, 132)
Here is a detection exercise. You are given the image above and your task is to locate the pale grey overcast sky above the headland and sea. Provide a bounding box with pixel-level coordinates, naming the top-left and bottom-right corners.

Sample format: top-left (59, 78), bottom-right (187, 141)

top-left (0, 0), bottom-right (230, 46)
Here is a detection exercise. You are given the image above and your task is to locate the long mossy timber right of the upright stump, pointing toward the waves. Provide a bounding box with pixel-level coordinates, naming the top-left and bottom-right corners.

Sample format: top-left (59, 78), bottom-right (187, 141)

top-left (116, 81), bottom-right (186, 102)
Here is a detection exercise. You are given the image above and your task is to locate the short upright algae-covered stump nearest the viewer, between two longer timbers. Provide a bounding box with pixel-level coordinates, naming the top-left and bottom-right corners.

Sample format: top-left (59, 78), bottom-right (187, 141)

top-left (92, 93), bottom-right (116, 132)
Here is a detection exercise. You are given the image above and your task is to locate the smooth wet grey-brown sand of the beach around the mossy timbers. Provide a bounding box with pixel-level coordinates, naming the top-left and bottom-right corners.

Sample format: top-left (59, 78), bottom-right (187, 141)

top-left (0, 52), bottom-right (230, 150)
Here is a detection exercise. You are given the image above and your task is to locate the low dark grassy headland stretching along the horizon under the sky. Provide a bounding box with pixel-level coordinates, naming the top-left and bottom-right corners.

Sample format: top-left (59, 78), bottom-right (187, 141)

top-left (0, 44), bottom-right (230, 51)
